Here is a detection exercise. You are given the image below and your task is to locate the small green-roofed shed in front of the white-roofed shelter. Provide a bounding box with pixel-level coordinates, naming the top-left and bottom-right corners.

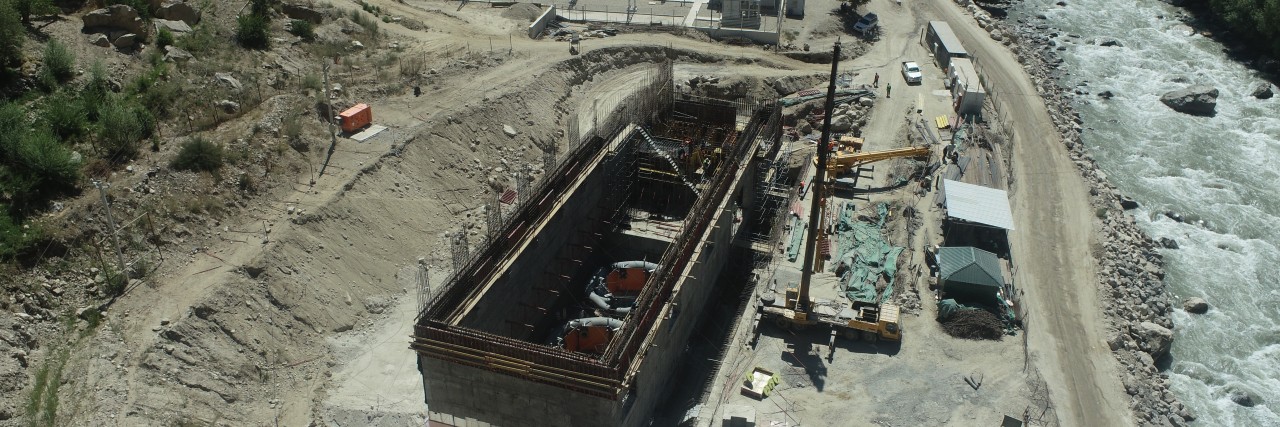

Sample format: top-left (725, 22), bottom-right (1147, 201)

top-left (938, 247), bottom-right (1005, 303)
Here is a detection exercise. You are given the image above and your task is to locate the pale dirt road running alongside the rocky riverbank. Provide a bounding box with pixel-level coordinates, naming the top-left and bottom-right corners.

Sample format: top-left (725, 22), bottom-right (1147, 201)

top-left (914, 0), bottom-right (1133, 426)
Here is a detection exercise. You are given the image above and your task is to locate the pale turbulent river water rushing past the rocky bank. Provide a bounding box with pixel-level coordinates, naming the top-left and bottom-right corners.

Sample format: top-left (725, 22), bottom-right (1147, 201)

top-left (1010, 0), bottom-right (1280, 426)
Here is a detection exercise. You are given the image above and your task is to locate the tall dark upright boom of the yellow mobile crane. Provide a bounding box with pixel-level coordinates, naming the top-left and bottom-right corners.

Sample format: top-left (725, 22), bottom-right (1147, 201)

top-left (796, 40), bottom-right (840, 318)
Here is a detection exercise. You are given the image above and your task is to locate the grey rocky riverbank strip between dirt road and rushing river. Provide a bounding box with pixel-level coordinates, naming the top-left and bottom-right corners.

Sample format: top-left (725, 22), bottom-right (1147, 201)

top-left (957, 0), bottom-right (1194, 426)
